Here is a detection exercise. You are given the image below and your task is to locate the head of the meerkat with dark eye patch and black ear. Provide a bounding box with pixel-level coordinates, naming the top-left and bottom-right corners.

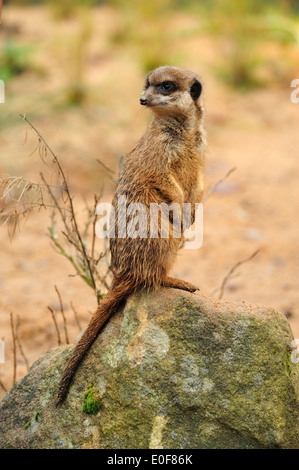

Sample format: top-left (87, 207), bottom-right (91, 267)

top-left (140, 66), bottom-right (203, 117)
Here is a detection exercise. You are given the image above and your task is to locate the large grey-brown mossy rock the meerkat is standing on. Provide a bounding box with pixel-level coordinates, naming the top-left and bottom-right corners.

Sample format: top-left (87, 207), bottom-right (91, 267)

top-left (0, 289), bottom-right (299, 449)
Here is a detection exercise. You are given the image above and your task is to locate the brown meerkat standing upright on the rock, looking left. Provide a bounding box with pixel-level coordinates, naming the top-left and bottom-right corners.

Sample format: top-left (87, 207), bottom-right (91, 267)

top-left (56, 66), bottom-right (206, 405)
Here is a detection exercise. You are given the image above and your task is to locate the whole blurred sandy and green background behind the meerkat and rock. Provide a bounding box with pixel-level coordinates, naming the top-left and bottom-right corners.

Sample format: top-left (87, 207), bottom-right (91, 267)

top-left (0, 0), bottom-right (299, 394)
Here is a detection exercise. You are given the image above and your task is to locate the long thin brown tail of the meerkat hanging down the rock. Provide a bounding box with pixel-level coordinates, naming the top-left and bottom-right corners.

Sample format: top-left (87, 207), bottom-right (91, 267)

top-left (56, 280), bottom-right (133, 406)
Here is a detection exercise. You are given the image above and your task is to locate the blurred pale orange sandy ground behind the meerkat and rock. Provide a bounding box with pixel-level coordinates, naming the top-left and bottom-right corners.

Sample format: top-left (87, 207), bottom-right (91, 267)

top-left (0, 8), bottom-right (299, 393)
